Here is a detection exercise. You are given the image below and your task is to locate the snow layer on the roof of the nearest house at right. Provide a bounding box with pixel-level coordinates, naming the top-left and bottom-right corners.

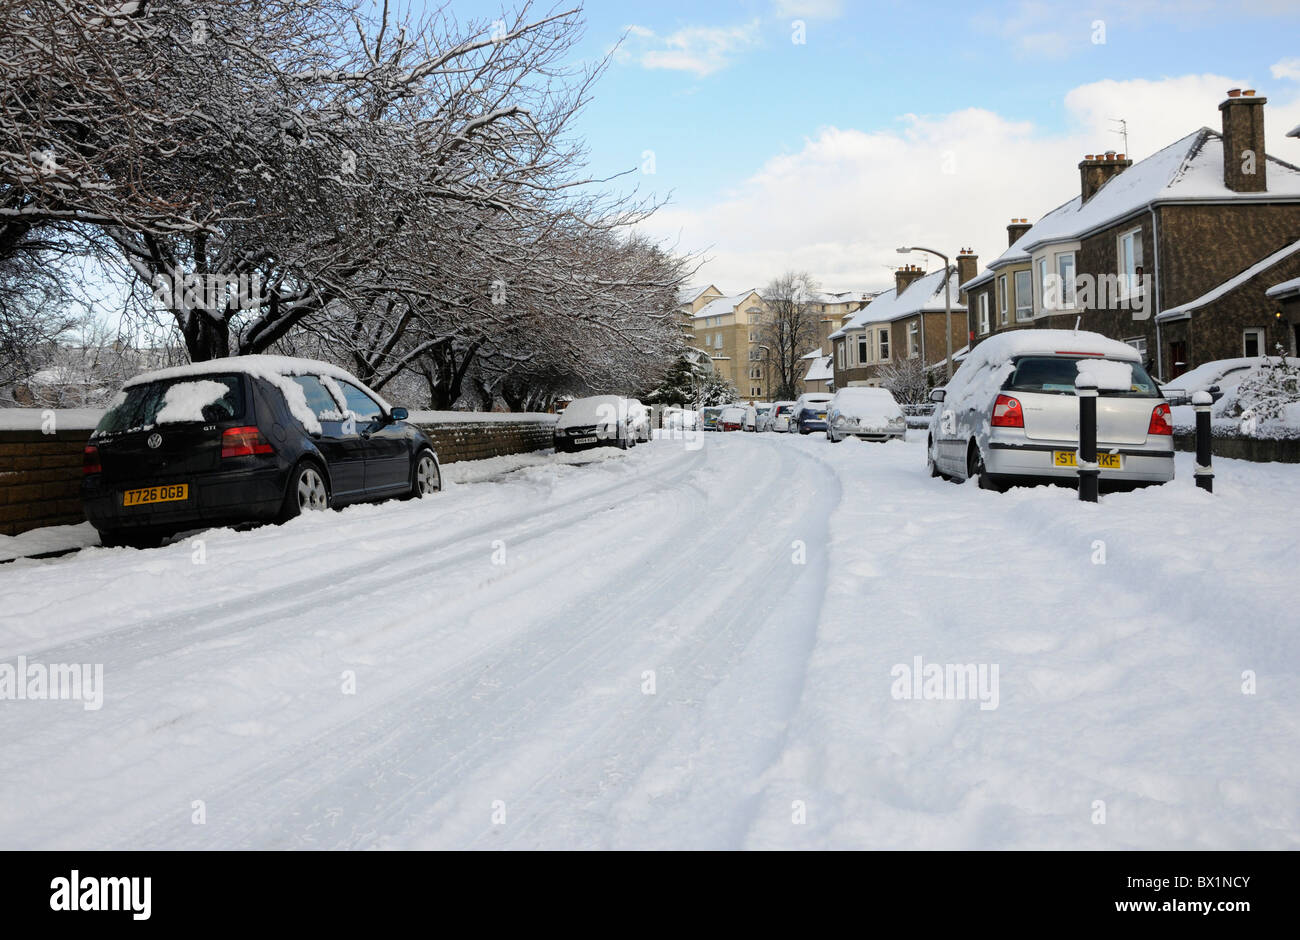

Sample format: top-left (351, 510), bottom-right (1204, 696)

top-left (962, 127), bottom-right (1300, 290)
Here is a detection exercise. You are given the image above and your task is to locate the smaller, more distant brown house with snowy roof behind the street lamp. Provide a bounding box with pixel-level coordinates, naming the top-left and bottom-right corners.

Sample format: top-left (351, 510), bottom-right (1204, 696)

top-left (829, 258), bottom-right (978, 389)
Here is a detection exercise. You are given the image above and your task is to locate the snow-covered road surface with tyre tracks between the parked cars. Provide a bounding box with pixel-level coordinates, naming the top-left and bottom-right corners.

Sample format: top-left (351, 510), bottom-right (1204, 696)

top-left (0, 432), bottom-right (1300, 849)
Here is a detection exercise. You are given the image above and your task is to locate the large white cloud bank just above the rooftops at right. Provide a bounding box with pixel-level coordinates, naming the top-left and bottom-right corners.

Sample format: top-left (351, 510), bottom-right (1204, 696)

top-left (646, 75), bottom-right (1300, 290)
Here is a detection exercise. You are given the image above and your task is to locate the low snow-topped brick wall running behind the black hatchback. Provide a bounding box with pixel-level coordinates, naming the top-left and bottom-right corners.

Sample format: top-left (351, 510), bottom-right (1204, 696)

top-left (0, 410), bottom-right (554, 536)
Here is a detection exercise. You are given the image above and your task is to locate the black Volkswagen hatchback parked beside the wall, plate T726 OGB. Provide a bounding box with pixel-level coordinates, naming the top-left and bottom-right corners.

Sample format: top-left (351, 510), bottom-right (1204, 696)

top-left (82, 356), bottom-right (442, 547)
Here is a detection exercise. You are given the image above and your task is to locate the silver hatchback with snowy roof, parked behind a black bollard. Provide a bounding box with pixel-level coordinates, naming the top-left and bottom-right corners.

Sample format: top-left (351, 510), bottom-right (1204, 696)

top-left (926, 330), bottom-right (1174, 489)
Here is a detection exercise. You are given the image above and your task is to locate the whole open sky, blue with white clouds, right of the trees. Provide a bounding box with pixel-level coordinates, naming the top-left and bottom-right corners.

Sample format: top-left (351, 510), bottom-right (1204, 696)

top-left (416, 0), bottom-right (1300, 289)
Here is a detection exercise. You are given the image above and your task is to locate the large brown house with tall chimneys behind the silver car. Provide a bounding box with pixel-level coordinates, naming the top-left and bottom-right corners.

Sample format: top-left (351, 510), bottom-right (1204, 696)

top-left (962, 88), bottom-right (1300, 381)
